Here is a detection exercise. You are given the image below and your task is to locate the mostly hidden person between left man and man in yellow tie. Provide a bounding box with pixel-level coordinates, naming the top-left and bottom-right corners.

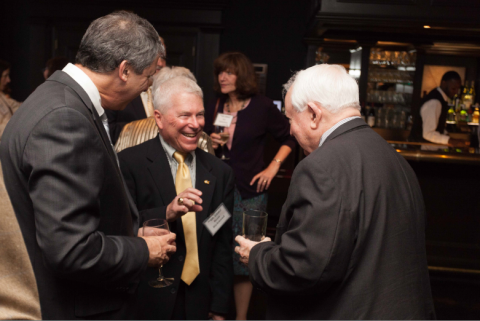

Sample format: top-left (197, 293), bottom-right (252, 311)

top-left (106, 37), bottom-right (167, 145)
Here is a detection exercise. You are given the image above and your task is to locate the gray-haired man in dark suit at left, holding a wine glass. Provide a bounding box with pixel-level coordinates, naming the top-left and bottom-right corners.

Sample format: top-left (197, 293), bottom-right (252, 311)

top-left (0, 11), bottom-right (175, 319)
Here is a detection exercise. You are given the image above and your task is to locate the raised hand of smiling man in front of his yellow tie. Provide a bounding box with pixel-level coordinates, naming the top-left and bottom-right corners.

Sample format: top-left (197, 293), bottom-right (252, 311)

top-left (166, 187), bottom-right (203, 222)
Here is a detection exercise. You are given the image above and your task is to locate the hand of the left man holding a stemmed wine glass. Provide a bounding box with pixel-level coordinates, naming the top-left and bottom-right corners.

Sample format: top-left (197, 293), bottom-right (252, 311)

top-left (141, 231), bottom-right (177, 267)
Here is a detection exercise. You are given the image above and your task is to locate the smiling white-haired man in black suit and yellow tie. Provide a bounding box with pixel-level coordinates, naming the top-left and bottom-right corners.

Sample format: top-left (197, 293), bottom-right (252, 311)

top-left (119, 77), bottom-right (234, 320)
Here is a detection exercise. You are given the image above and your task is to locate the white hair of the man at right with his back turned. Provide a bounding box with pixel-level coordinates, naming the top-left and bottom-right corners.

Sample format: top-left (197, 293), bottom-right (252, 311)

top-left (283, 64), bottom-right (360, 114)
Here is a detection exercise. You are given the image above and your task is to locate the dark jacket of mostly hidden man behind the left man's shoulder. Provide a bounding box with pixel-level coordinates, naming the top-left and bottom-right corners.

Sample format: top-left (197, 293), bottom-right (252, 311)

top-left (105, 96), bottom-right (147, 146)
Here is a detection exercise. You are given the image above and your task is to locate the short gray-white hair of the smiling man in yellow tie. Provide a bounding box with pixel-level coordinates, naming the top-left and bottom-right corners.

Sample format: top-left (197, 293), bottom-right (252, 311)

top-left (152, 76), bottom-right (203, 114)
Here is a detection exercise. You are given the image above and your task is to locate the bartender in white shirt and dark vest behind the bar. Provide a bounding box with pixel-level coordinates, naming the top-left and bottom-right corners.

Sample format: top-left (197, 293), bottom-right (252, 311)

top-left (409, 71), bottom-right (465, 147)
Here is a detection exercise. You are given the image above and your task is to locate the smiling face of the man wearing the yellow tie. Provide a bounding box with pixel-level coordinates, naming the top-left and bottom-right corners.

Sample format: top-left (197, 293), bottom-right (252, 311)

top-left (155, 93), bottom-right (205, 153)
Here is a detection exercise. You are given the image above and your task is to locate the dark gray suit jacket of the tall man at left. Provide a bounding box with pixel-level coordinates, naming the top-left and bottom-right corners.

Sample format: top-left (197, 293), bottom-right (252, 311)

top-left (0, 71), bottom-right (148, 319)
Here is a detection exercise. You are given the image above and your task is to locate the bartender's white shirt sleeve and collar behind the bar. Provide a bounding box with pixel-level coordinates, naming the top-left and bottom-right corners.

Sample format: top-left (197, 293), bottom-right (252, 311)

top-left (420, 87), bottom-right (450, 145)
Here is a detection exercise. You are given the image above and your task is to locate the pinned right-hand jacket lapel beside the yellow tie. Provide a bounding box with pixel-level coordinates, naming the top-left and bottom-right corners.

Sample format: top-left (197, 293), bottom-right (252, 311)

top-left (195, 148), bottom-right (217, 244)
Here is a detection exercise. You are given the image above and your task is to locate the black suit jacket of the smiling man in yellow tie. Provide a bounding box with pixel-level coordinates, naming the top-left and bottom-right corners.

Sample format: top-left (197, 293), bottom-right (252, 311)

top-left (119, 136), bottom-right (234, 320)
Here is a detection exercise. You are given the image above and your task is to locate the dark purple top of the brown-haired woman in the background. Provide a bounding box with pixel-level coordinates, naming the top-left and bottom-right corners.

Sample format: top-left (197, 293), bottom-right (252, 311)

top-left (204, 95), bottom-right (296, 199)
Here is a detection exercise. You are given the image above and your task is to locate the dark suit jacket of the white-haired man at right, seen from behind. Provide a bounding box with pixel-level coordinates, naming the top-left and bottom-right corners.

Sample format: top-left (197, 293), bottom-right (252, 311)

top-left (249, 119), bottom-right (435, 320)
